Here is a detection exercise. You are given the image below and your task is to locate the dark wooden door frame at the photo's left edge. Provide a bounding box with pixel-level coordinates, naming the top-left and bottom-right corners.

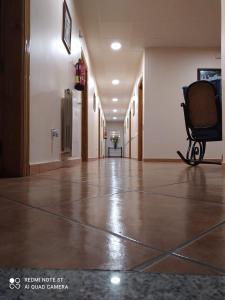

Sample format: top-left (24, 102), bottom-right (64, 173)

top-left (0, 0), bottom-right (30, 177)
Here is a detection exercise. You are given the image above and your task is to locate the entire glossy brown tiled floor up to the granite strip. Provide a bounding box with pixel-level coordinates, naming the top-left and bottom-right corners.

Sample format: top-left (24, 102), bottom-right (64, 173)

top-left (0, 159), bottom-right (225, 274)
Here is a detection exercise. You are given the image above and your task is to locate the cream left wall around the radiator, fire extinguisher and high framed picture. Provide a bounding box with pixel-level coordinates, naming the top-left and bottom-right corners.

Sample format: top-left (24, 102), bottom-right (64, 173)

top-left (30, 0), bottom-right (104, 164)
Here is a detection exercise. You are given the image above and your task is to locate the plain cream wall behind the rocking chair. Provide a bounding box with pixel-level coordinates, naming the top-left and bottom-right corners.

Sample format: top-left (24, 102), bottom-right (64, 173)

top-left (144, 48), bottom-right (222, 159)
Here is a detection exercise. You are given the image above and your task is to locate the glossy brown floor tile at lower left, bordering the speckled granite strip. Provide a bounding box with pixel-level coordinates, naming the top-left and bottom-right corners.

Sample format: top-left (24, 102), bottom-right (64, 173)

top-left (0, 198), bottom-right (160, 270)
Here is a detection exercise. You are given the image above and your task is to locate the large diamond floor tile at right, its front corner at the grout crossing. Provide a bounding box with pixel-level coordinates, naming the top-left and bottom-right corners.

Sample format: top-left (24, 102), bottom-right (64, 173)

top-left (40, 192), bottom-right (225, 250)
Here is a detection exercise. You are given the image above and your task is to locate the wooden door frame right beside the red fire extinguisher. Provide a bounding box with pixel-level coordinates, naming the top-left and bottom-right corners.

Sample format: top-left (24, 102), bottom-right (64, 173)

top-left (81, 51), bottom-right (88, 162)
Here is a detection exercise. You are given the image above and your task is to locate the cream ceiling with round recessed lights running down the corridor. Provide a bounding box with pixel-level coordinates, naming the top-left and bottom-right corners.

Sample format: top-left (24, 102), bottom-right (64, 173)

top-left (75, 0), bottom-right (221, 120)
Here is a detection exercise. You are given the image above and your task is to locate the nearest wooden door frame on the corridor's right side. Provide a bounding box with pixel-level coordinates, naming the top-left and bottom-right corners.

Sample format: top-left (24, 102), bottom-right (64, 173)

top-left (138, 78), bottom-right (143, 161)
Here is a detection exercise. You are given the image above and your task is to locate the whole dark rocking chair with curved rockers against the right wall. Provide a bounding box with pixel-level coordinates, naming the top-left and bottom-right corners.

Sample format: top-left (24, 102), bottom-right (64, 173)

top-left (177, 80), bottom-right (222, 166)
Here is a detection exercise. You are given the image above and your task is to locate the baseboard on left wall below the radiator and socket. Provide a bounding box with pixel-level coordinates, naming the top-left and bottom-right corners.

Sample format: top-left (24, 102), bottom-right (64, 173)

top-left (30, 159), bottom-right (81, 175)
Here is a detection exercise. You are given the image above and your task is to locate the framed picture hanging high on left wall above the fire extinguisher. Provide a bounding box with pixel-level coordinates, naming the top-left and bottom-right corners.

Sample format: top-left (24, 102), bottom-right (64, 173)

top-left (62, 0), bottom-right (72, 54)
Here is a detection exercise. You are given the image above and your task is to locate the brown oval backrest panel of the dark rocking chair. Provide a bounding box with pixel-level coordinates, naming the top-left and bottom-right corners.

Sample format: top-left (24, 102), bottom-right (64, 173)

top-left (185, 80), bottom-right (220, 128)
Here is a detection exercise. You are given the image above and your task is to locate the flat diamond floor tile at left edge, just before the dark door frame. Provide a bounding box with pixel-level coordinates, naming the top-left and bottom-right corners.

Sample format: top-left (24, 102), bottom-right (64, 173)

top-left (0, 178), bottom-right (120, 206)
